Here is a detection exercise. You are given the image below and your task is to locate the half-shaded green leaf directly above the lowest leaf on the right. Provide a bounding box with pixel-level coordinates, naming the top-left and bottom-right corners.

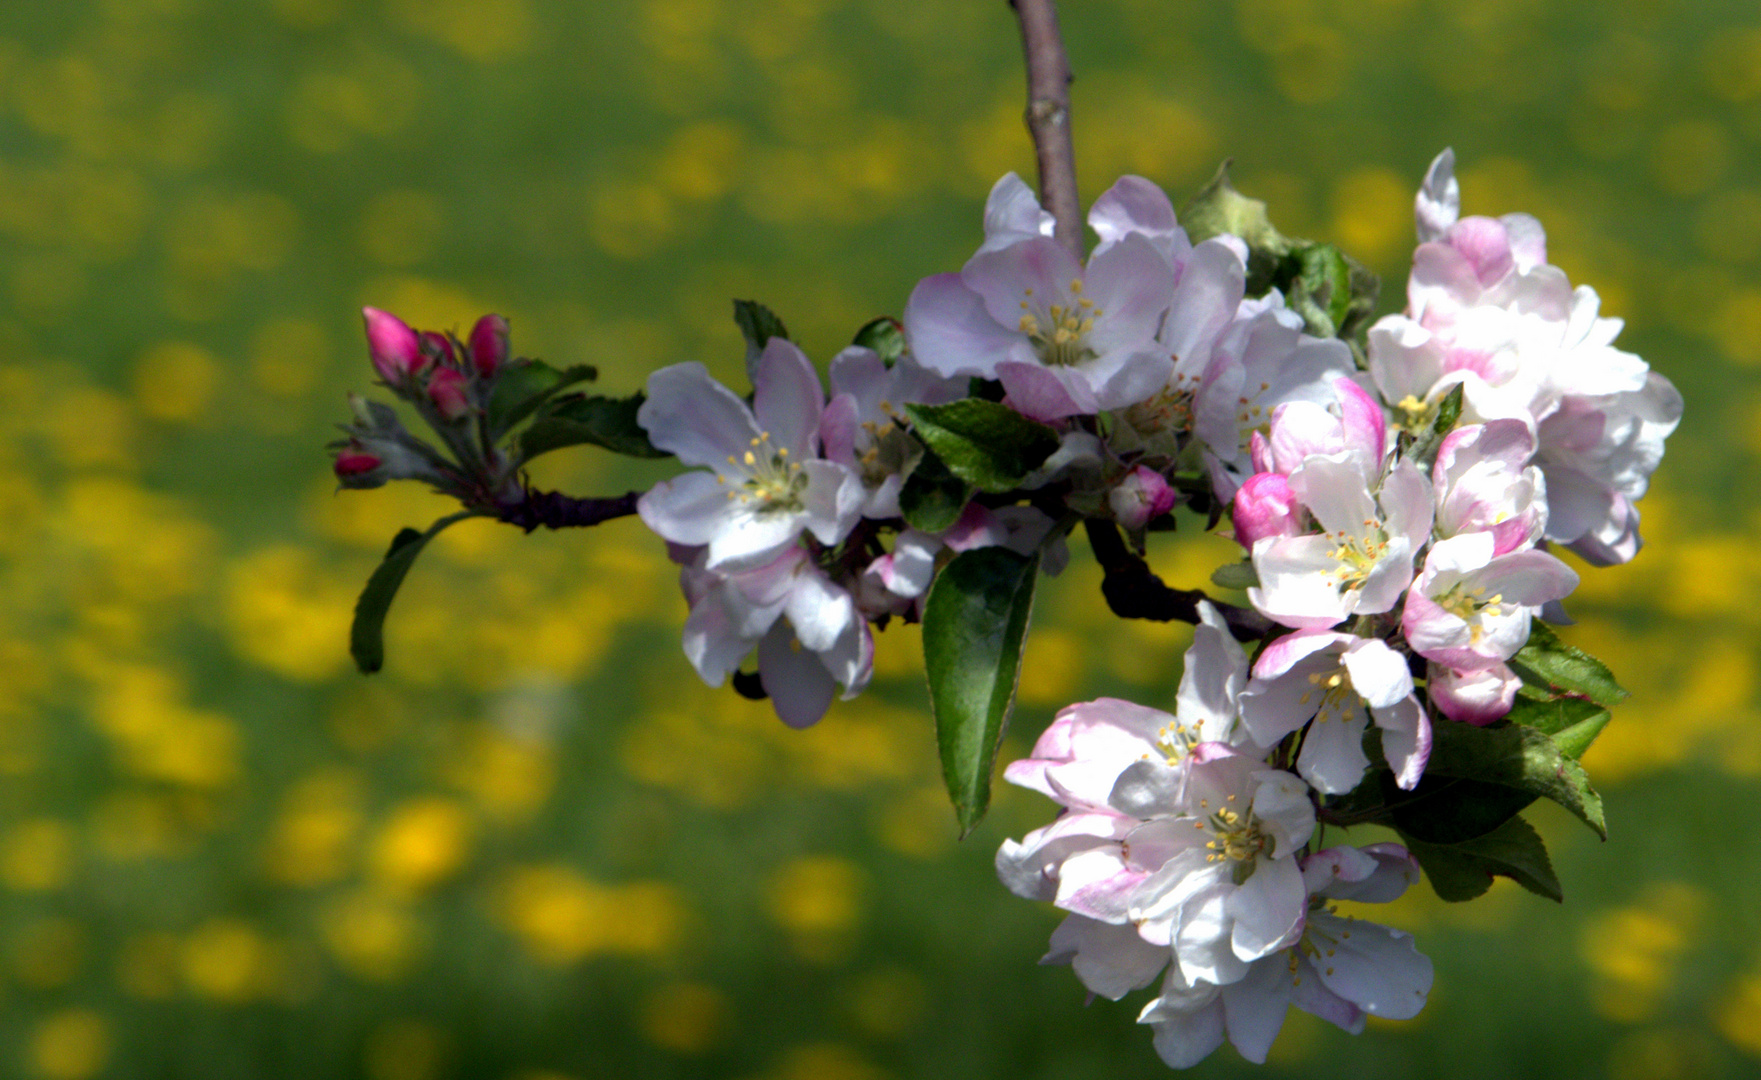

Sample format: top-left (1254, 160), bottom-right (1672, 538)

top-left (1425, 719), bottom-right (1608, 840)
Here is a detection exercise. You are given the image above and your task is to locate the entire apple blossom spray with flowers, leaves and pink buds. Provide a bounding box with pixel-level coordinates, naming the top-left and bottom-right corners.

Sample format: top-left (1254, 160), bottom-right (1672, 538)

top-left (335, 152), bottom-right (1682, 1068)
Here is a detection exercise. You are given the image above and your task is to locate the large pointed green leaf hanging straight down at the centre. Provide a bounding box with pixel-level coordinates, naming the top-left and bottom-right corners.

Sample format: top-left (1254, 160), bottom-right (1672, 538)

top-left (923, 548), bottom-right (1039, 835)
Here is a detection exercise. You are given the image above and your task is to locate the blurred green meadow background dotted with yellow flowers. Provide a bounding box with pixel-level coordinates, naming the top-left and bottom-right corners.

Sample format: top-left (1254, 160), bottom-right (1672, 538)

top-left (0, 0), bottom-right (1761, 1080)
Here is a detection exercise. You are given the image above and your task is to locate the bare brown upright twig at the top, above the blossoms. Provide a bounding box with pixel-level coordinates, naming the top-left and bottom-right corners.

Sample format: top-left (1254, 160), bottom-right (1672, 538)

top-left (1009, 0), bottom-right (1083, 259)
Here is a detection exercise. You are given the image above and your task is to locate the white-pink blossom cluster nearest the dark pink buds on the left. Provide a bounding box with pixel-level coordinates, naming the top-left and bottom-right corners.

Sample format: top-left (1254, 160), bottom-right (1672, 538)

top-left (637, 337), bottom-right (1053, 728)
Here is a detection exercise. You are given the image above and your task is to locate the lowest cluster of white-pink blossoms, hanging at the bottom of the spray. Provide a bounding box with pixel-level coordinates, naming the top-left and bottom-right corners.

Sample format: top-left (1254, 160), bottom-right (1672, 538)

top-left (997, 623), bottom-right (1432, 1068)
